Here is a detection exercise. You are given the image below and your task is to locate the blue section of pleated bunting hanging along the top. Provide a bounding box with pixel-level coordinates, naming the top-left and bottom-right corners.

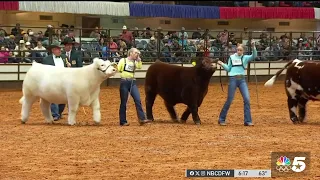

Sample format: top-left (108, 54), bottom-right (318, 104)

top-left (129, 3), bottom-right (220, 19)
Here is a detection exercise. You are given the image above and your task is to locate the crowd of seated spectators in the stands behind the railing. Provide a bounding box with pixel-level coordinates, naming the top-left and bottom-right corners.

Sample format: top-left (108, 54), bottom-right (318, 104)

top-left (0, 24), bottom-right (320, 63)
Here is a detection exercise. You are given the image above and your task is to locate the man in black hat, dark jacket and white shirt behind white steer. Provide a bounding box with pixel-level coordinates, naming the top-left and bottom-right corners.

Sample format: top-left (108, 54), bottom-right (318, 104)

top-left (42, 45), bottom-right (71, 121)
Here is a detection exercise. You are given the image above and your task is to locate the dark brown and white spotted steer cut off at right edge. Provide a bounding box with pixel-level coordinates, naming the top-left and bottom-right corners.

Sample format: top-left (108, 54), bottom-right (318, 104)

top-left (265, 59), bottom-right (320, 123)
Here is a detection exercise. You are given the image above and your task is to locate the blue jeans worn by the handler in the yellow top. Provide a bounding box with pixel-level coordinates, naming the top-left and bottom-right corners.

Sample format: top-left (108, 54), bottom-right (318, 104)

top-left (119, 79), bottom-right (146, 125)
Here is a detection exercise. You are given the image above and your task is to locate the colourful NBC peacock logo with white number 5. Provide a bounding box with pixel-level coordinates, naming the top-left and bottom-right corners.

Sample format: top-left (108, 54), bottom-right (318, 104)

top-left (276, 156), bottom-right (306, 173)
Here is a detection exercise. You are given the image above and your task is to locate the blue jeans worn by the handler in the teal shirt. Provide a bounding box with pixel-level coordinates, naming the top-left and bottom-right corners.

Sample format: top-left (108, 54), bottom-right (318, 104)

top-left (219, 76), bottom-right (252, 123)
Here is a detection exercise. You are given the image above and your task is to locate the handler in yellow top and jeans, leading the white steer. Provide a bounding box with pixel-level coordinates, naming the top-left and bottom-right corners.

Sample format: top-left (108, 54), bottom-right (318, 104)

top-left (118, 48), bottom-right (150, 126)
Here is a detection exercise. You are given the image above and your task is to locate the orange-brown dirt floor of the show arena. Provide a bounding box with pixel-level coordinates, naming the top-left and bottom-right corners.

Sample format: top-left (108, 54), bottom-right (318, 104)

top-left (0, 83), bottom-right (320, 180)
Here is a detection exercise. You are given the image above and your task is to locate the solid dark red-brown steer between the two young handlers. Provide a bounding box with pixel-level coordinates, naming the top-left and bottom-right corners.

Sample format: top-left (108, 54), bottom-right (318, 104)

top-left (145, 57), bottom-right (216, 124)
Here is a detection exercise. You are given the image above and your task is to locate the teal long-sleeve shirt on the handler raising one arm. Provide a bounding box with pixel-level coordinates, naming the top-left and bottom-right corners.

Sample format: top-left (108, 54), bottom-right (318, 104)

top-left (222, 47), bottom-right (257, 76)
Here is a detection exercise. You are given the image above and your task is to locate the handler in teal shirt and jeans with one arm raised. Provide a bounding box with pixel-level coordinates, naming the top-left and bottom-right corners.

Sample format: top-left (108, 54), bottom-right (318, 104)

top-left (218, 41), bottom-right (257, 126)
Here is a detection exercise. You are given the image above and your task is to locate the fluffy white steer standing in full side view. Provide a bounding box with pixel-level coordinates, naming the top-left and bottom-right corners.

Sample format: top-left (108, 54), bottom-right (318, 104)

top-left (19, 58), bottom-right (117, 125)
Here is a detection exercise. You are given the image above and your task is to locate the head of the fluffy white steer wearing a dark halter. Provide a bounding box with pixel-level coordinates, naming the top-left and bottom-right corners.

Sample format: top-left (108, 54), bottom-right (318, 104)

top-left (93, 58), bottom-right (117, 78)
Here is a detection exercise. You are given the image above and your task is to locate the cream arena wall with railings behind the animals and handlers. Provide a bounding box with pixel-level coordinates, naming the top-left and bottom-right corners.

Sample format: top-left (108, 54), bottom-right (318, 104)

top-left (0, 62), bottom-right (287, 90)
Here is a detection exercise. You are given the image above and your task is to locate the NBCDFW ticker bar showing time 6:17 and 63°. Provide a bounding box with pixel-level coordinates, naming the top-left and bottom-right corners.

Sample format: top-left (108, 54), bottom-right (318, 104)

top-left (186, 169), bottom-right (271, 177)
